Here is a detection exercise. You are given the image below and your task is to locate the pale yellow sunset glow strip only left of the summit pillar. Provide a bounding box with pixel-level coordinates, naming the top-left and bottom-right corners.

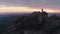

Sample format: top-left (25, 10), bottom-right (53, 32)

top-left (0, 7), bottom-right (39, 12)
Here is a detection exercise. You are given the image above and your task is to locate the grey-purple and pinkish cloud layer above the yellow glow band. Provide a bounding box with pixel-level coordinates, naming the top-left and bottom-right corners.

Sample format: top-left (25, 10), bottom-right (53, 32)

top-left (0, 0), bottom-right (60, 9)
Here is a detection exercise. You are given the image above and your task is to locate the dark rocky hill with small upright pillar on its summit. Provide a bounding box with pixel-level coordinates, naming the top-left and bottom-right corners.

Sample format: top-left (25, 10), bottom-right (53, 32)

top-left (3, 9), bottom-right (60, 34)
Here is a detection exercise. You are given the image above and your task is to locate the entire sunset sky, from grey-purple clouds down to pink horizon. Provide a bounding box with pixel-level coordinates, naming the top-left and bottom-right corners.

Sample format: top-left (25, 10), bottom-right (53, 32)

top-left (0, 0), bottom-right (60, 13)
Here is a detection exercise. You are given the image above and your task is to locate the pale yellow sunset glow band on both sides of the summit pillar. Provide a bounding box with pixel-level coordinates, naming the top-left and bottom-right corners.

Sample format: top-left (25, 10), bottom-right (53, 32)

top-left (0, 7), bottom-right (60, 13)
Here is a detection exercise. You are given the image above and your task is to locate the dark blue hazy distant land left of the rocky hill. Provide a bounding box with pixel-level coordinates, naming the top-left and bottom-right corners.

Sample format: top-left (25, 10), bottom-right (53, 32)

top-left (0, 14), bottom-right (28, 34)
